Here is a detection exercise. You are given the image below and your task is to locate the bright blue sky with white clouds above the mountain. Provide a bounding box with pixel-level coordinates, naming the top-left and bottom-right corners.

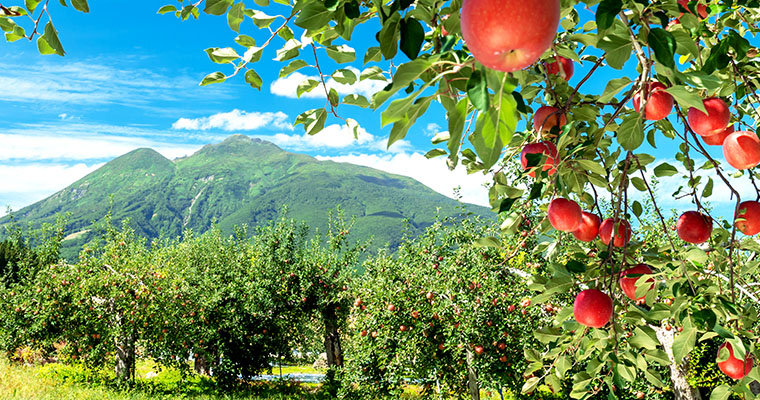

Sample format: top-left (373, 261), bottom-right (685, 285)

top-left (0, 0), bottom-right (748, 222)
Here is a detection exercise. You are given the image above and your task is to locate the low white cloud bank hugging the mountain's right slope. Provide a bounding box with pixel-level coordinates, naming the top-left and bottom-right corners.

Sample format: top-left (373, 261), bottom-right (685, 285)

top-left (317, 153), bottom-right (491, 207)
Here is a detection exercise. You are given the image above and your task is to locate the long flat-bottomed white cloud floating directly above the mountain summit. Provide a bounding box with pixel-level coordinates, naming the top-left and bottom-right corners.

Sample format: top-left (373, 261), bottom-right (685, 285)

top-left (172, 109), bottom-right (293, 131)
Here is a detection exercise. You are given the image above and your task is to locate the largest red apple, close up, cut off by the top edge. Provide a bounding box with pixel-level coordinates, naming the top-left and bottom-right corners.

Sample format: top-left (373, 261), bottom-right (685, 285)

top-left (460, 0), bottom-right (560, 72)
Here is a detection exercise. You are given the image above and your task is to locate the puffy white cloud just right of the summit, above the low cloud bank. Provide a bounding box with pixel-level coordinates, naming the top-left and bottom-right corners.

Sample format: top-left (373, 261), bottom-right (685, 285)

top-left (259, 124), bottom-right (411, 152)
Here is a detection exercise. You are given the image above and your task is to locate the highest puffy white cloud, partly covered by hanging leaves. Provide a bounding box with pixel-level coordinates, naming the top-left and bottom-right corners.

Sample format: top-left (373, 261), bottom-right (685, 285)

top-left (269, 68), bottom-right (388, 100)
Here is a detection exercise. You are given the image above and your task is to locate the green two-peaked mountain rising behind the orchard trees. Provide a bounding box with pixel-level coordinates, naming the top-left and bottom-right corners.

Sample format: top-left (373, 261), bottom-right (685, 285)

top-left (0, 135), bottom-right (494, 258)
